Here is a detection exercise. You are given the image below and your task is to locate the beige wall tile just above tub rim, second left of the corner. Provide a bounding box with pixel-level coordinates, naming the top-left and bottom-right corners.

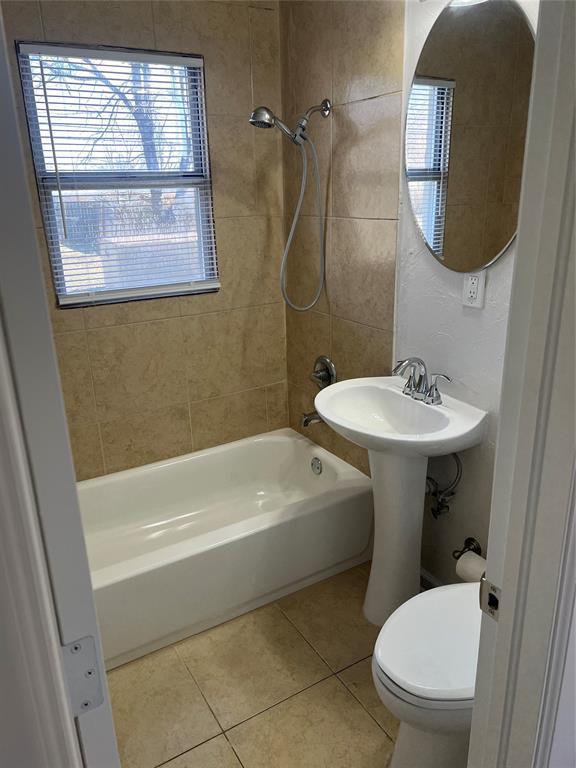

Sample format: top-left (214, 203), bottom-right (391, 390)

top-left (190, 388), bottom-right (268, 450)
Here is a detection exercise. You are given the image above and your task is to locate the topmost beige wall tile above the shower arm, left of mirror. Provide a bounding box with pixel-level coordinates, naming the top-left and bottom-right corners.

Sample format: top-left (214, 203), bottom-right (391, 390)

top-left (333, 0), bottom-right (404, 104)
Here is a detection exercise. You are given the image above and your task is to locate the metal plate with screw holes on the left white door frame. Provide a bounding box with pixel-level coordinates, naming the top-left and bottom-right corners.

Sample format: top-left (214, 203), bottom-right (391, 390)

top-left (62, 636), bottom-right (104, 717)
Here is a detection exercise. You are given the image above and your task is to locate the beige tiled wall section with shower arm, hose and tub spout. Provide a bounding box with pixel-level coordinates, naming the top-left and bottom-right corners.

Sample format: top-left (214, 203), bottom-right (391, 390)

top-left (280, 0), bottom-right (404, 471)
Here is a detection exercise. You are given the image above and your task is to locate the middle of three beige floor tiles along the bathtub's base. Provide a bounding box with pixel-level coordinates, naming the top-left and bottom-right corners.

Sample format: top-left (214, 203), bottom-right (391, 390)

top-left (177, 605), bottom-right (330, 729)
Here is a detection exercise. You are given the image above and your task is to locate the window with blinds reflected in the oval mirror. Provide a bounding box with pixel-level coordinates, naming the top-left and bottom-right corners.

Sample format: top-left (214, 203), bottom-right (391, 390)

top-left (406, 77), bottom-right (455, 258)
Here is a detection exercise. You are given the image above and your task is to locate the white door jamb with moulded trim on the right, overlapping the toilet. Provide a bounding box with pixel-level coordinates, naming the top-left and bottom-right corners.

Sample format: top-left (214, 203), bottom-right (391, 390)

top-left (468, 0), bottom-right (576, 768)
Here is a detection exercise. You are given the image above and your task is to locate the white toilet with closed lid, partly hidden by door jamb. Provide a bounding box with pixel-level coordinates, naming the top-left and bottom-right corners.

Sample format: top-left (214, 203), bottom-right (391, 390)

top-left (372, 582), bottom-right (482, 768)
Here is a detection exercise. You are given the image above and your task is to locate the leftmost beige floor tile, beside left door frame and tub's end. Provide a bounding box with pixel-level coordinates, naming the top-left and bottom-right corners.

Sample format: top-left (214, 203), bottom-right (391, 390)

top-left (108, 648), bottom-right (220, 768)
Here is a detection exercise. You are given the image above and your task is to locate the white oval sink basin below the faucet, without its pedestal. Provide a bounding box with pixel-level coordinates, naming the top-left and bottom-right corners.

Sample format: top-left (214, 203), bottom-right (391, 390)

top-left (314, 376), bottom-right (487, 456)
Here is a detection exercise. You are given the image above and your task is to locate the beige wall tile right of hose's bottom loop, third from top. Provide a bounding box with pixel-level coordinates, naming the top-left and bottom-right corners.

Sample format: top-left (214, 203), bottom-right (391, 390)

top-left (326, 219), bottom-right (397, 330)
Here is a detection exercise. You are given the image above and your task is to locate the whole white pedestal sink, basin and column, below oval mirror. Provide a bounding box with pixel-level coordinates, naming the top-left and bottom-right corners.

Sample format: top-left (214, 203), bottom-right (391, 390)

top-left (314, 376), bottom-right (487, 625)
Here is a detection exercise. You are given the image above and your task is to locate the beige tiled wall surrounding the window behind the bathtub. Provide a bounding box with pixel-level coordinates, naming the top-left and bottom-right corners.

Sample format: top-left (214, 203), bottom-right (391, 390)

top-left (2, 0), bottom-right (288, 479)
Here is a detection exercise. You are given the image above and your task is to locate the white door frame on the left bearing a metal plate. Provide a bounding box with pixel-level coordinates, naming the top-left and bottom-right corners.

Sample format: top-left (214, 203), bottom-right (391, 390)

top-left (0, 19), bottom-right (120, 768)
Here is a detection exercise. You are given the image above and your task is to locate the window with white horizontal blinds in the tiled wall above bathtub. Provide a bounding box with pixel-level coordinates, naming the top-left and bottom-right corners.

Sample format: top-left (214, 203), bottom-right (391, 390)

top-left (19, 43), bottom-right (219, 306)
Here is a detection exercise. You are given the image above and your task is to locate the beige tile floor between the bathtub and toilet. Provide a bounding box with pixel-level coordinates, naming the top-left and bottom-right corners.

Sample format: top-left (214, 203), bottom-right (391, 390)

top-left (108, 565), bottom-right (398, 768)
